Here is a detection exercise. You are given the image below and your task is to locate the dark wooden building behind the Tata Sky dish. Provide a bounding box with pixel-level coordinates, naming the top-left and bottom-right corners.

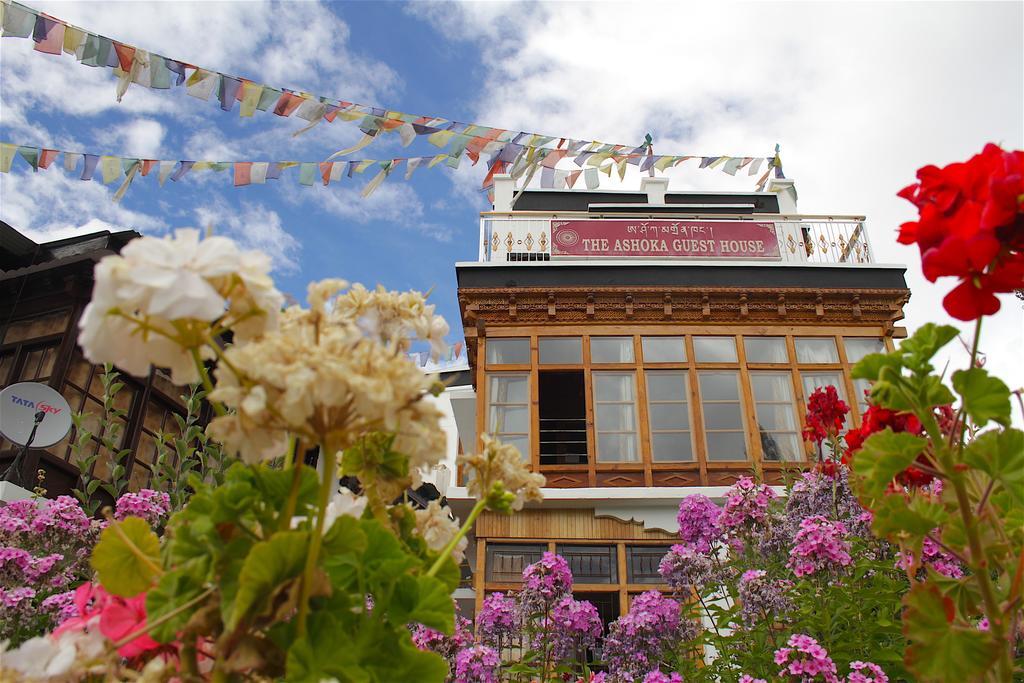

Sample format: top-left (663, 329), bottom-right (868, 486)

top-left (0, 223), bottom-right (206, 502)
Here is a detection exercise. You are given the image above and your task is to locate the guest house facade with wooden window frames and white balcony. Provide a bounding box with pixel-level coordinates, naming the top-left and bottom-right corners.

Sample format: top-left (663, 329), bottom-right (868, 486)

top-left (442, 178), bottom-right (909, 622)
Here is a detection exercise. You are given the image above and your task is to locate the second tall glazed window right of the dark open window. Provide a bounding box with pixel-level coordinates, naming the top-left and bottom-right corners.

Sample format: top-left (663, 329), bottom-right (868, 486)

top-left (644, 370), bottom-right (694, 462)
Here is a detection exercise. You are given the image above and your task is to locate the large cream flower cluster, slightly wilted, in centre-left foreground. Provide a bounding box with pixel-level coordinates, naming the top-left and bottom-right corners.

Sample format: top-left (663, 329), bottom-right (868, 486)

top-left (208, 280), bottom-right (445, 475)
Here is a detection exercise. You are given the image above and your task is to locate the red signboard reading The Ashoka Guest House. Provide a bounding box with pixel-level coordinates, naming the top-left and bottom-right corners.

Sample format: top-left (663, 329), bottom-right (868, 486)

top-left (551, 220), bottom-right (780, 258)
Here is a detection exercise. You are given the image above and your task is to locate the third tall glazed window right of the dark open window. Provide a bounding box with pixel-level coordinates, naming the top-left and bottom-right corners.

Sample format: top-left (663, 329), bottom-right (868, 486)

top-left (698, 370), bottom-right (748, 461)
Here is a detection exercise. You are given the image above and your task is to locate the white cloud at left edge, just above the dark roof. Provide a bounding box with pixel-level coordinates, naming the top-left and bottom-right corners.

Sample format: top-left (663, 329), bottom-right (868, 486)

top-left (0, 161), bottom-right (167, 242)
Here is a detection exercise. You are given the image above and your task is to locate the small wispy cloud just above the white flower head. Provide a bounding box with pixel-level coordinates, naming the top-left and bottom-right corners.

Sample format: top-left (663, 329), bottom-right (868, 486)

top-left (195, 198), bottom-right (302, 272)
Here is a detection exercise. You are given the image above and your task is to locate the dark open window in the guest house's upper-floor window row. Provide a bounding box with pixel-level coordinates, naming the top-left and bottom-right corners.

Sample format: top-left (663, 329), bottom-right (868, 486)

top-left (539, 370), bottom-right (587, 465)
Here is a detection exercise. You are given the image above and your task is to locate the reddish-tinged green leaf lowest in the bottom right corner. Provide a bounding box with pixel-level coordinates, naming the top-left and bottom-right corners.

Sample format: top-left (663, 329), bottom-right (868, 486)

top-left (903, 584), bottom-right (998, 683)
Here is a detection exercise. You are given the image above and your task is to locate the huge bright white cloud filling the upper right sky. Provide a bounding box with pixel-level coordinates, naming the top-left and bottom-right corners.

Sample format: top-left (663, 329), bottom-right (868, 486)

top-left (421, 2), bottom-right (1024, 417)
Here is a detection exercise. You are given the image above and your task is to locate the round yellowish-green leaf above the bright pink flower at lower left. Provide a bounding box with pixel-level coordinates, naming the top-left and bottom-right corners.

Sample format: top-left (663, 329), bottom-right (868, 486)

top-left (90, 517), bottom-right (161, 598)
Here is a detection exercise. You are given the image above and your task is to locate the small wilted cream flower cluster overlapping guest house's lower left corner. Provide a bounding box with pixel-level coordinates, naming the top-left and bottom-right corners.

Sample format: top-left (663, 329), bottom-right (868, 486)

top-left (459, 434), bottom-right (546, 513)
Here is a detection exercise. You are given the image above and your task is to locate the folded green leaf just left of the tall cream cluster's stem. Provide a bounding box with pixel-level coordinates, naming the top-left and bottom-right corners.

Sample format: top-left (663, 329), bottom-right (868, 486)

top-left (226, 531), bottom-right (309, 630)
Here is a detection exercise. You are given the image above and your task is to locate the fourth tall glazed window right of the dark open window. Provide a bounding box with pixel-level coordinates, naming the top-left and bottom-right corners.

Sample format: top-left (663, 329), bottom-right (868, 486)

top-left (751, 372), bottom-right (804, 462)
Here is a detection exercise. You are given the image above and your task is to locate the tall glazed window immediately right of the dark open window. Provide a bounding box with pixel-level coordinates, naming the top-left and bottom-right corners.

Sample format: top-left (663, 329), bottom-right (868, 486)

top-left (593, 372), bottom-right (640, 463)
